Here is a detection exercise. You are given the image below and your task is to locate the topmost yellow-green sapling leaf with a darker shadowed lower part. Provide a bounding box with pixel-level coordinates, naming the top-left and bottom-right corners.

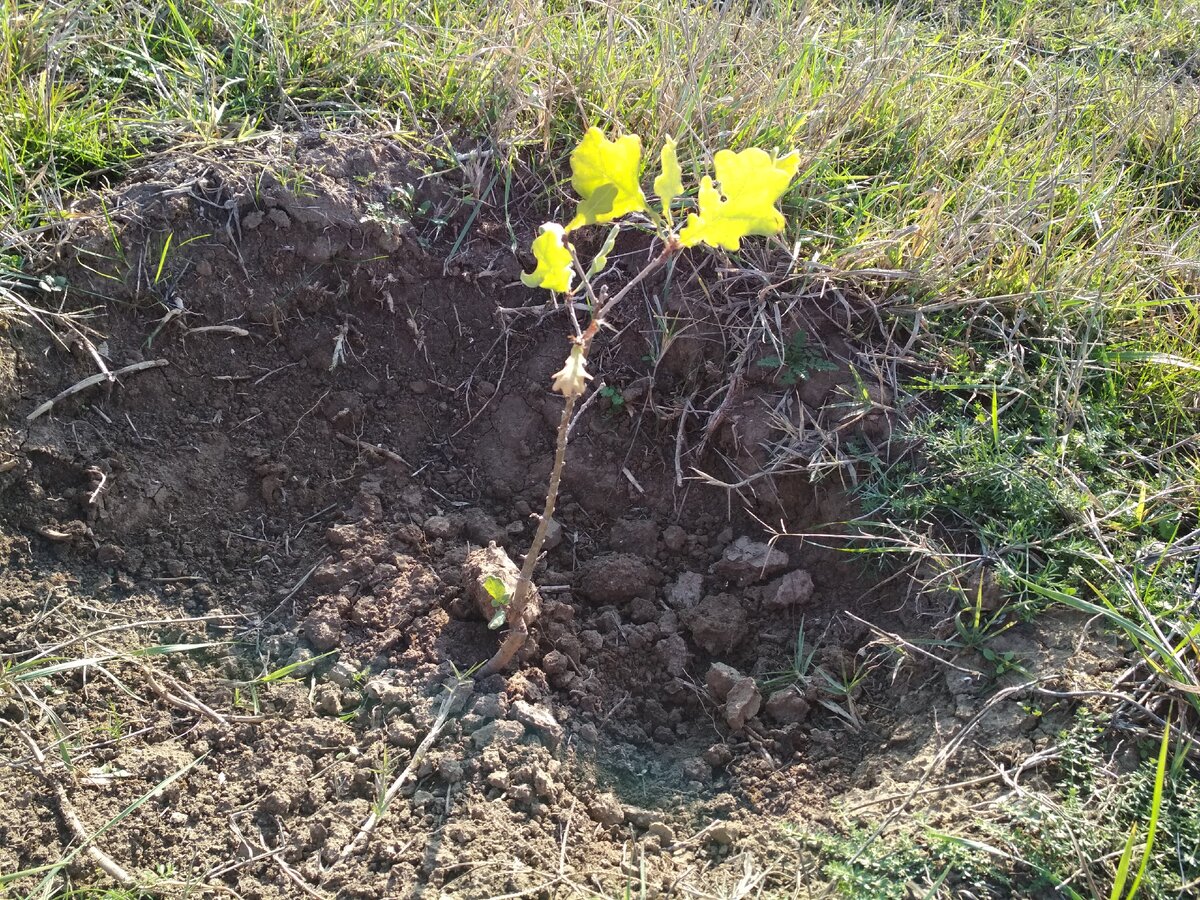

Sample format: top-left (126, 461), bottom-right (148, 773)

top-left (566, 128), bottom-right (647, 232)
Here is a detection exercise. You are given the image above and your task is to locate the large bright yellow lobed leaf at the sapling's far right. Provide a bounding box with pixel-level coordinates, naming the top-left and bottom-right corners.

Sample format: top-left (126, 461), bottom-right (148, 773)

top-left (679, 148), bottom-right (800, 250)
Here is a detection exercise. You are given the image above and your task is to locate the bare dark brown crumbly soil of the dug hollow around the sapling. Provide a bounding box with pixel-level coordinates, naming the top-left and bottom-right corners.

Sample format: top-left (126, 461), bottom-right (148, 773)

top-left (0, 136), bottom-right (1116, 898)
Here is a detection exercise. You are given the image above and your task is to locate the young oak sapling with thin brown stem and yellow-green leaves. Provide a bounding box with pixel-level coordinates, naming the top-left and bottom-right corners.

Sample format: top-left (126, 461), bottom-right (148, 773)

top-left (481, 128), bottom-right (800, 676)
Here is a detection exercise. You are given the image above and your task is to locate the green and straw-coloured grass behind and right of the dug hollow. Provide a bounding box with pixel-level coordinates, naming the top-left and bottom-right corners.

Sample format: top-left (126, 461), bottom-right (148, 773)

top-left (0, 0), bottom-right (1200, 890)
